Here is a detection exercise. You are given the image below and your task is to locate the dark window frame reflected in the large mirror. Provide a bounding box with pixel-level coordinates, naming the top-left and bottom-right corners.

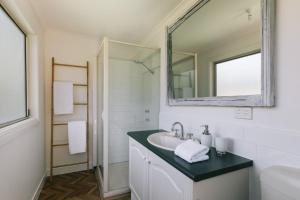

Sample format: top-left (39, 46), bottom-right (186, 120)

top-left (213, 49), bottom-right (262, 96)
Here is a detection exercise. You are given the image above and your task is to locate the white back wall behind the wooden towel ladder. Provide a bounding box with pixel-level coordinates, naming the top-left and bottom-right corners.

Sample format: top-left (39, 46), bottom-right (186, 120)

top-left (45, 30), bottom-right (99, 174)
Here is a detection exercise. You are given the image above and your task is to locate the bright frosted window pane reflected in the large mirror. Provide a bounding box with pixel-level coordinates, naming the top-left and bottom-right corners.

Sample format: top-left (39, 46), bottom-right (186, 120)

top-left (216, 53), bottom-right (261, 96)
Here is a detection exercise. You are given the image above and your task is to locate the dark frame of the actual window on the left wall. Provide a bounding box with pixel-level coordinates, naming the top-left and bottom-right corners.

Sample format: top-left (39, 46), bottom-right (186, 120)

top-left (0, 4), bottom-right (30, 129)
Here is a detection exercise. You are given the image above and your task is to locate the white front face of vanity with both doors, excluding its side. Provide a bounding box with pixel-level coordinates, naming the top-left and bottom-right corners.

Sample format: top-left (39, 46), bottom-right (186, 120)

top-left (129, 139), bottom-right (193, 200)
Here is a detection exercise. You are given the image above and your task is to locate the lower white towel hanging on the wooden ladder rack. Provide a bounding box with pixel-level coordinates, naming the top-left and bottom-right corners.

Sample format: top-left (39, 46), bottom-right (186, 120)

top-left (68, 121), bottom-right (86, 154)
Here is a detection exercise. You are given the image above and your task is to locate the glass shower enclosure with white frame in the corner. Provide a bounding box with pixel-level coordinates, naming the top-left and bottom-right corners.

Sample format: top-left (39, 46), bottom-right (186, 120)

top-left (97, 38), bottom-right (160, 197)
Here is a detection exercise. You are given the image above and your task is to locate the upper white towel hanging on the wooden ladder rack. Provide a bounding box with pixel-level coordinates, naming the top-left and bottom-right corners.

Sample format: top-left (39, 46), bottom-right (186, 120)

top-left (53, 81), bottom-right (73, 115)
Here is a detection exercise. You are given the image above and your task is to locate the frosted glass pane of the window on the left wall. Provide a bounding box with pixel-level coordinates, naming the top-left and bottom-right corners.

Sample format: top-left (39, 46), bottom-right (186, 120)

top-left (0, 7), bottom-right (27, 128)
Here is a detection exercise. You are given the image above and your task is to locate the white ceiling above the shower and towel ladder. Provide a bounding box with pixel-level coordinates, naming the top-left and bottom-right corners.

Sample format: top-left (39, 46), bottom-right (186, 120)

top-left (30, 0), bottom-right (181, 42)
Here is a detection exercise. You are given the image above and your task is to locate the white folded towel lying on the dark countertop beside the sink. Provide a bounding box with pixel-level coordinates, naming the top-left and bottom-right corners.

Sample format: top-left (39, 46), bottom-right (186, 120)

top-left (175, 140), bottom-right (209, 163)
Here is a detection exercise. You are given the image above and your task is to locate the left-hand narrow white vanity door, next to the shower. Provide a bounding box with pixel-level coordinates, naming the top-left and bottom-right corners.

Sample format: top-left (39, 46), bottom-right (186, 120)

top-left (129, 139), bottom-right (148, 200)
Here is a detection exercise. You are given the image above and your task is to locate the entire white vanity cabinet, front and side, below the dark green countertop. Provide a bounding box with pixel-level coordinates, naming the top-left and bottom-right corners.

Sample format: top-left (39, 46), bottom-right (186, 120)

top-left (129, 138), bottom-right (249, 200)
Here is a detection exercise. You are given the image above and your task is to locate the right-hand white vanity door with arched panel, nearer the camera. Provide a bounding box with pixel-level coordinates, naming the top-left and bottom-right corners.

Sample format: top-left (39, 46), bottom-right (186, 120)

top-left (148, 152), bottom-right (187, 200)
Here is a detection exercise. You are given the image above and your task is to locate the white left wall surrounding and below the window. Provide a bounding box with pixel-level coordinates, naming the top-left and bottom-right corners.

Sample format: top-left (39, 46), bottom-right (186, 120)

top-left (0, 0), bottom-right (45, 200)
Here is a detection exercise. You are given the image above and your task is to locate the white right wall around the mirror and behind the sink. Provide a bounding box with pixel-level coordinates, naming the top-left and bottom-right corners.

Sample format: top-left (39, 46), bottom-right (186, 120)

top-left (145, 0), bottom-right (300, 200)
